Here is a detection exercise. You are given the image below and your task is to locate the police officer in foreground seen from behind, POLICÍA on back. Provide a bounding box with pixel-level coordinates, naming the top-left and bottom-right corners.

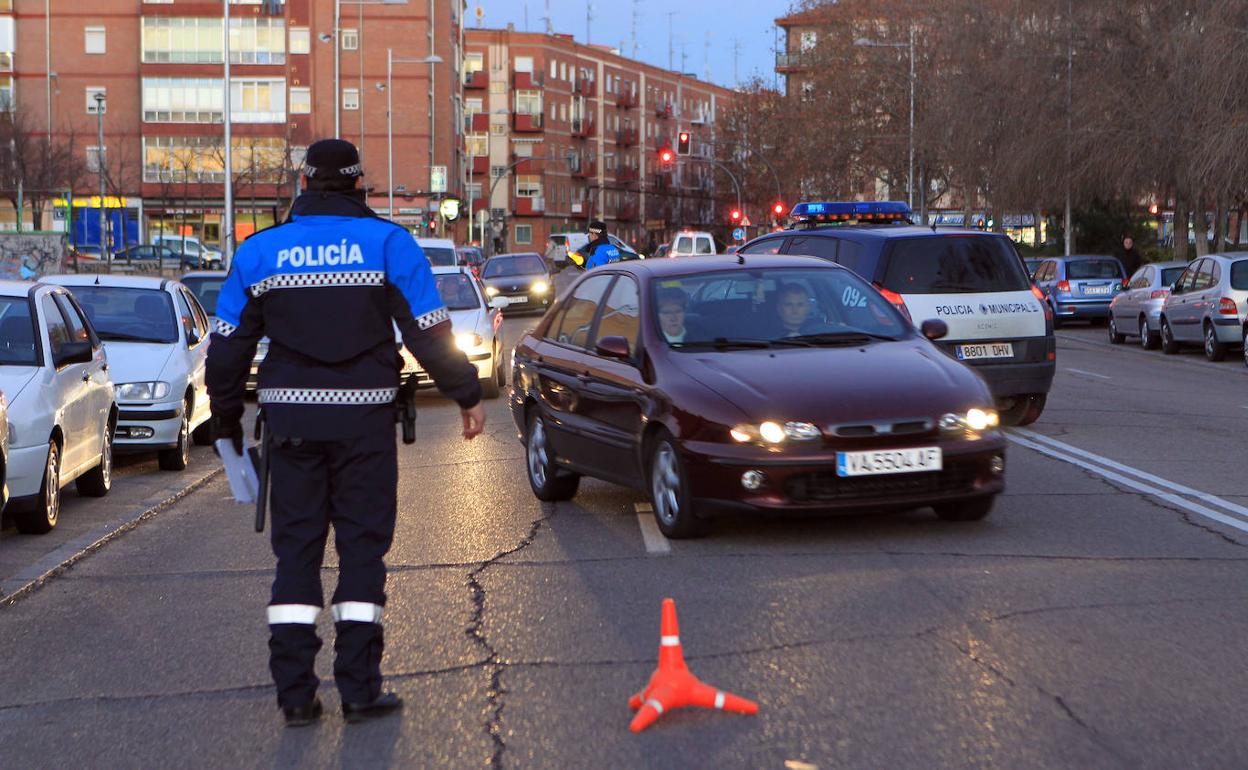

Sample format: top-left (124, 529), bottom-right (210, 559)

top-left (207, 140), bottom-right (484, 726)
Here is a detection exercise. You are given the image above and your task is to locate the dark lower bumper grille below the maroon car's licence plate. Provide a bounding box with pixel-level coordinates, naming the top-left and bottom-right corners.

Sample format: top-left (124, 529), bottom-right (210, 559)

top-left (784, 463), bottom-right (978, 503)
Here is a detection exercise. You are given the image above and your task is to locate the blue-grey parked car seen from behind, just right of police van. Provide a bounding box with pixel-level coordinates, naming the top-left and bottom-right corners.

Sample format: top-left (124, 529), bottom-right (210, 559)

top-left (1033, 256), bottom-right (1127, 327)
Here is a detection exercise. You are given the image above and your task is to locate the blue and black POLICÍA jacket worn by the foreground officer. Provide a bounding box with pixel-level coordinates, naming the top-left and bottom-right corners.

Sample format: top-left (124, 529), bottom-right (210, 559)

top-left (207, 192), bottom-right (480, 441)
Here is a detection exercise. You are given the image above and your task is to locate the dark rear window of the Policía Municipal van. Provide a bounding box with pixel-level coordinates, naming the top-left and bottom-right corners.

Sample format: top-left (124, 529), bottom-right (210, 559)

top-left (882, 235), bottom-right (1030, 295)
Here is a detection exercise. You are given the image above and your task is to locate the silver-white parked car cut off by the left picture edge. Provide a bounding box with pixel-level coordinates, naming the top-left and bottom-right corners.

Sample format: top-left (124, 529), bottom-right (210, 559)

top-left (0, 281), bottom-right (117, 534)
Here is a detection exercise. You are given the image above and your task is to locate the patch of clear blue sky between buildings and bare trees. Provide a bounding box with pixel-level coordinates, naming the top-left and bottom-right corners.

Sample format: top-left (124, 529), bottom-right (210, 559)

top-left (467, 0), bottom-right (789, 87)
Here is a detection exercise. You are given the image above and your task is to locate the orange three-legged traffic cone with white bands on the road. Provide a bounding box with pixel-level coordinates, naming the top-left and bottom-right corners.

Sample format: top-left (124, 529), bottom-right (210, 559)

top-left (628, 599), bottom-right (759, 733)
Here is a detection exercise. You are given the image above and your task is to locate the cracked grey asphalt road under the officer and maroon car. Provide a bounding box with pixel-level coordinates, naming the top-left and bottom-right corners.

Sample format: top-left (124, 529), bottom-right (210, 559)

top-left (0, 285), bottom-right (1248, 769)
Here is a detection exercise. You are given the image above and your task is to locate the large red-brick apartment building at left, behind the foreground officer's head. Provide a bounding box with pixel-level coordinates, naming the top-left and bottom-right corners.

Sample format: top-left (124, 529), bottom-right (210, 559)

top-left (7, 0), bottom-right (463, 246)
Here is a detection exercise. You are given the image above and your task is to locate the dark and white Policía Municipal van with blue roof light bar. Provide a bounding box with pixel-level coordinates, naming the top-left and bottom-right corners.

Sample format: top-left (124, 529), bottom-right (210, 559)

top-left (738, 201), bottom-right (1057, 426)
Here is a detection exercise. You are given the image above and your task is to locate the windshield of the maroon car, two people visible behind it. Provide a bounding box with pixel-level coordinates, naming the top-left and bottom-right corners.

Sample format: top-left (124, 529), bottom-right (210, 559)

top-left (651, 268), bottom-right (910, 349)
